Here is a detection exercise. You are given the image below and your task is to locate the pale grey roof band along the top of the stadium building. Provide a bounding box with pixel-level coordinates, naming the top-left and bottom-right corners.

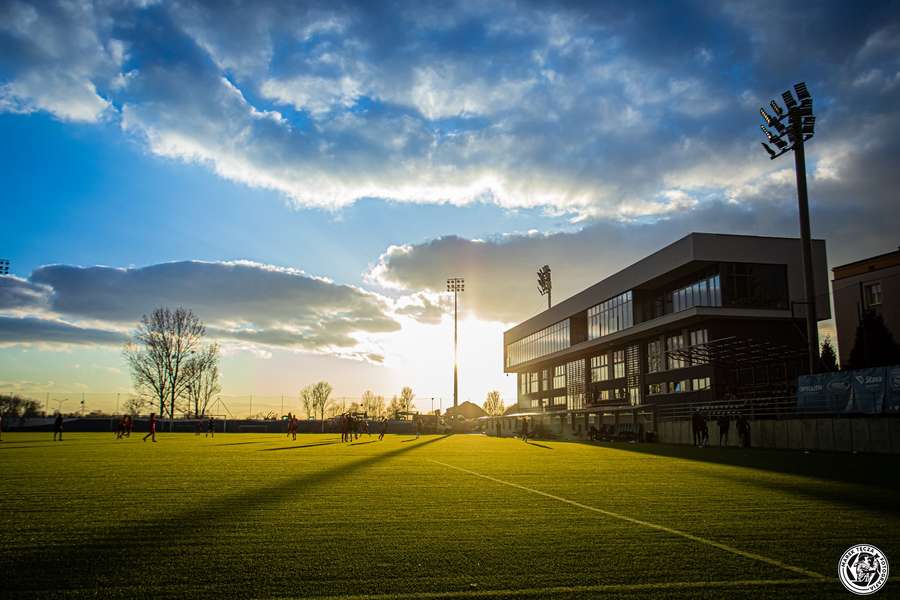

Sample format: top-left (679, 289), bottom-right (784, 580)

top-left (503, 232), bottom-right (831, 344)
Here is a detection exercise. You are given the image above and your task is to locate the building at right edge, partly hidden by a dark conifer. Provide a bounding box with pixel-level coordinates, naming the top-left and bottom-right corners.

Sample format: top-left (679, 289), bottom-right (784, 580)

top-left (831, 249), bottom-right (900, 364)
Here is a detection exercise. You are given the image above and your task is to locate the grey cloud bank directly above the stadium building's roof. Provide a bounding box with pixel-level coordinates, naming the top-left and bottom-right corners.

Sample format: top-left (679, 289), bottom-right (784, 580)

top-left (368, 196), bottom-right (891, 323)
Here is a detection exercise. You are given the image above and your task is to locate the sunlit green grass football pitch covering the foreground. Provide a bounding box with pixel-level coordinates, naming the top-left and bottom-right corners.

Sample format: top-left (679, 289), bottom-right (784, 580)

top-left (0, 433), bottom-right (900, 598)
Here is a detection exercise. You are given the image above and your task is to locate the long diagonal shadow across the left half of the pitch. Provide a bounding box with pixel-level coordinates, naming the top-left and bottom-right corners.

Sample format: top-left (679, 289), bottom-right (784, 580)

top-left (3, 435), bottom-right (450, 596)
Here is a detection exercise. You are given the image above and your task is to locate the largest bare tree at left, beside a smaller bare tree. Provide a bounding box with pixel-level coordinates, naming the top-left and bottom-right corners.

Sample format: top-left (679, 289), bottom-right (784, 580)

top-left (124, 307), bottom-right (206, 426)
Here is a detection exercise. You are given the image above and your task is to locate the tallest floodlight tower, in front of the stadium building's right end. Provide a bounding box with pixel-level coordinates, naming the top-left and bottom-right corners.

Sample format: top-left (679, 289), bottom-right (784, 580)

top-left (759, 81), bottom-right (819, 373)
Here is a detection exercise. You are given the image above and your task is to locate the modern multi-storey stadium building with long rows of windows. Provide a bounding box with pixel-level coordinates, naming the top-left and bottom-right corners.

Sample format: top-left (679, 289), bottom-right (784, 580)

top-left (503, 233), bottom-right (831, 416)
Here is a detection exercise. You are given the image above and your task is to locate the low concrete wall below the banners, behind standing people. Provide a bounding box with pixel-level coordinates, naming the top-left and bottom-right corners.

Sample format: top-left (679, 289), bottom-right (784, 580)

top-left (657, 416), bottom-right (900, 454)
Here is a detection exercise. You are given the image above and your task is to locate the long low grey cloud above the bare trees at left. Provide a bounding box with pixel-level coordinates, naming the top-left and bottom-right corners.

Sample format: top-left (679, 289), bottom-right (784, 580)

top-left (0, 261), bottom-right (400, 352)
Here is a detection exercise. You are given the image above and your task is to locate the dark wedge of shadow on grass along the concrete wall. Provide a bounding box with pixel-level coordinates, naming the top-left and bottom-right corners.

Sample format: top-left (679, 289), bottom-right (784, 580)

top-left (596, 442), bottom-right (900, 492)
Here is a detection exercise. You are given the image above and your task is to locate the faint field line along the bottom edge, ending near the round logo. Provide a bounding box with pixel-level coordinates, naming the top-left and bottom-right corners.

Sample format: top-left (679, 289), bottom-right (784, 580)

top-left (298, 578), bottom-right (837, 600)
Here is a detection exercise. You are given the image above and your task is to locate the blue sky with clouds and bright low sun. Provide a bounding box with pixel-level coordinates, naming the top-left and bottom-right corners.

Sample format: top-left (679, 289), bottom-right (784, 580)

top-left (0, 0), bottom-right (900, 409)
